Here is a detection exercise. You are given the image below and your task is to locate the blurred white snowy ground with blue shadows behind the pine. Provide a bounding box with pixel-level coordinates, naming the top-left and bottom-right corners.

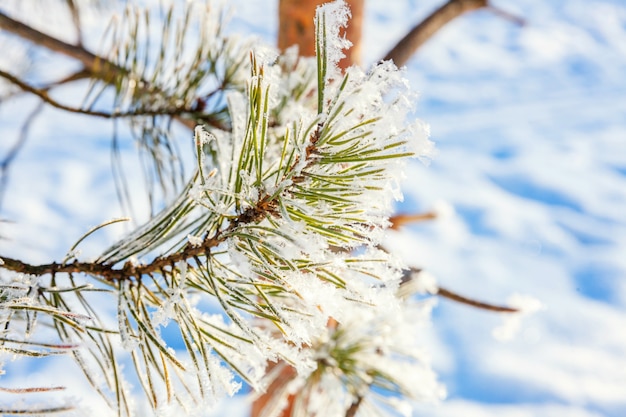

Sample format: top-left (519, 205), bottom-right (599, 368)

top-left (0, 0), bottom-right (626, 417)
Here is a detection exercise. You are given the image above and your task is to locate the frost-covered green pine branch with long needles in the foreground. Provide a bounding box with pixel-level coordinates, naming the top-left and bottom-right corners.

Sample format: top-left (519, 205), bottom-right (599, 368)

top-left (0, 1), bottom-right (448, 416)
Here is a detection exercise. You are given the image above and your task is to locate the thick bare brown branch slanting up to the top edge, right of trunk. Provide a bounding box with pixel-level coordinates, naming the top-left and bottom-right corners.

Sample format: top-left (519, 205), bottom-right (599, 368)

top-left (383, 0), bottom-right (488, 67)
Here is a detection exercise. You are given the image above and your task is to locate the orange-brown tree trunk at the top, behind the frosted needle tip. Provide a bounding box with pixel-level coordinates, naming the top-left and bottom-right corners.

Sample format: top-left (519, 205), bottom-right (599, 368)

top-left (278, 0), bottom-right (365, 68)
